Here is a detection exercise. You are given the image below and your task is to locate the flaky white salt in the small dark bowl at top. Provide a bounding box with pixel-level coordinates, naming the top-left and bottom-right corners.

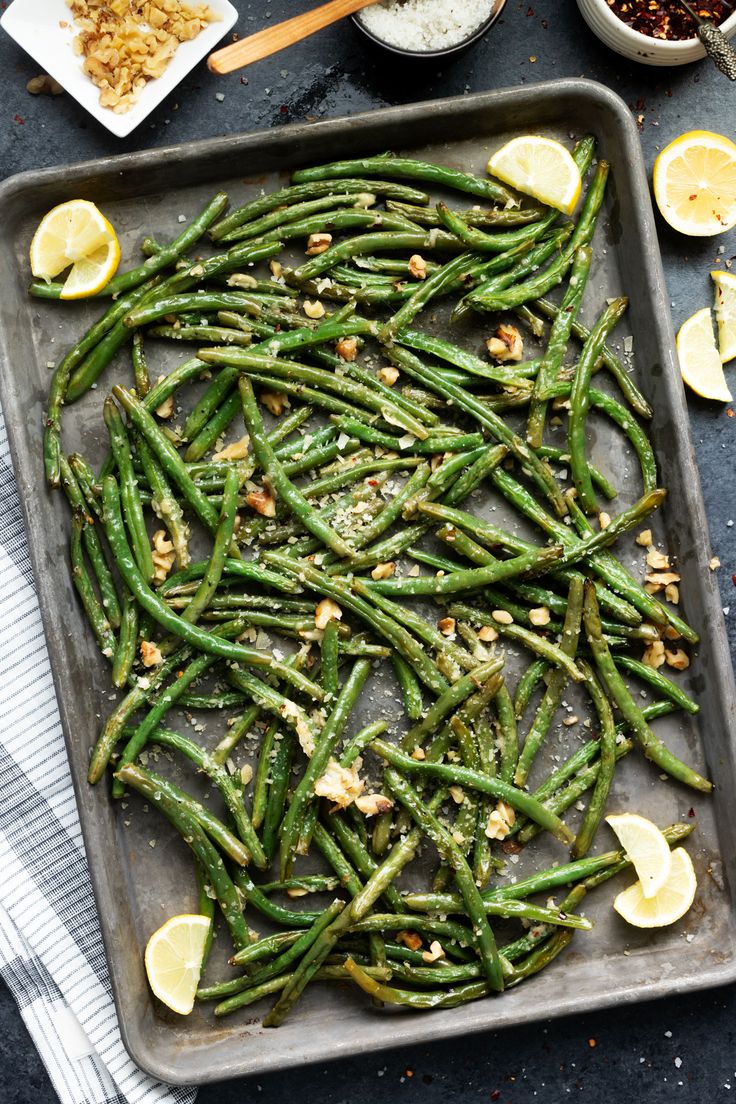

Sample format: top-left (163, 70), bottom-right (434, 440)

top-left (359, 0), bottom-right (492, 52)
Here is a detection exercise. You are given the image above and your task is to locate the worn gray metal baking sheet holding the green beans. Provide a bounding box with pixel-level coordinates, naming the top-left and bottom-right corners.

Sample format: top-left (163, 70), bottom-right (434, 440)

top-left (0, 81), bottom-right (736, 1083)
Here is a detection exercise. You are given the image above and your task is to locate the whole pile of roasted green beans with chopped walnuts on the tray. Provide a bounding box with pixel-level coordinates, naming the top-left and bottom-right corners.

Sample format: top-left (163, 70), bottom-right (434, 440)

top-left (38, 137), bottom-right (712, 1027)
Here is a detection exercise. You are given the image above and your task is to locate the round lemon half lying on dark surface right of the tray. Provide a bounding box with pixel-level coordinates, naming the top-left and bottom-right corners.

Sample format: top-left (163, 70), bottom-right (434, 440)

top-left (653, 130), bottom-right (736, 237)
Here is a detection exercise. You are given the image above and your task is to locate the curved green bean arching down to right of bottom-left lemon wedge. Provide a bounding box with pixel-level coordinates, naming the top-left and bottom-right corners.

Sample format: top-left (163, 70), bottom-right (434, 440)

top-left (116, 763), bottom-right (250, 951)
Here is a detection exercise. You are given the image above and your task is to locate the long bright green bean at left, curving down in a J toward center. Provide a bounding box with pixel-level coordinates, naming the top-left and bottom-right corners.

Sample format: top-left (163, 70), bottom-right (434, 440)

top-left (103, 476), bottom-right (323, 701)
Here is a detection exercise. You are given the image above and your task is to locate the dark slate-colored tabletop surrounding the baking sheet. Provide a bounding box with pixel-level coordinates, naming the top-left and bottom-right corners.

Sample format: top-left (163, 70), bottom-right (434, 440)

top-left (0, 0), bottom-right (736, 1104)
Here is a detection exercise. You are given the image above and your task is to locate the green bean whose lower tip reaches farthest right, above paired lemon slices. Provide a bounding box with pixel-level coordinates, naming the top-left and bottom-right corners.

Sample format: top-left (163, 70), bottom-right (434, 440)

top-left (583, 583), bottom-right (713, 794)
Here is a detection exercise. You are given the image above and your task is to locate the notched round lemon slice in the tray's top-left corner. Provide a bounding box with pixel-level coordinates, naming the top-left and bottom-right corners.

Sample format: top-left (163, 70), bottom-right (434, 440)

top-left (30, 200), bottom-right (120, 299)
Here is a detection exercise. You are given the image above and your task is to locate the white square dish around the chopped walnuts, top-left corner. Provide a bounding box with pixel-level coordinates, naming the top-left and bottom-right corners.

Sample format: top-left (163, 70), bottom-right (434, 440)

top-left (0, 0), bottom-right (237, 138)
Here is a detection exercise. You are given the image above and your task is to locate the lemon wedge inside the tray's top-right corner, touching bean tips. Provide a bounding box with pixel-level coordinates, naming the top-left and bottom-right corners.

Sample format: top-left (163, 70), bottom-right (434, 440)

top-left (487, 135), bottom-right (583, 214)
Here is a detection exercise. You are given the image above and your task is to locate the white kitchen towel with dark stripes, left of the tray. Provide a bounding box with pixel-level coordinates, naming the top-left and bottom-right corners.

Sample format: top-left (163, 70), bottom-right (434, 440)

top-left (0, 414), bottom-right (196, 1104)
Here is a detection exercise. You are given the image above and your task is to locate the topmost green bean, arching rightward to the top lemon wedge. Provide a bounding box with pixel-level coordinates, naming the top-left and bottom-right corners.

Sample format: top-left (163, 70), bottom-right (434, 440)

top-left (291, 153), bottom-right (515, 206)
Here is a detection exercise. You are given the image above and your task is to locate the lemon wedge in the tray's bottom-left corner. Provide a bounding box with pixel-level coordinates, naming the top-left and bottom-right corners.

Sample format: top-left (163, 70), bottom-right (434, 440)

top-left (146, 913), bottom-right (210, 1016)
